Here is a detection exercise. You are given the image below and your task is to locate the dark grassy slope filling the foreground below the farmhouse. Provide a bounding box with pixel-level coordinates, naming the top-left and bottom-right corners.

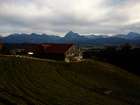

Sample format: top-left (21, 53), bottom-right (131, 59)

top-left (0, 57), bottom-right (140, 105)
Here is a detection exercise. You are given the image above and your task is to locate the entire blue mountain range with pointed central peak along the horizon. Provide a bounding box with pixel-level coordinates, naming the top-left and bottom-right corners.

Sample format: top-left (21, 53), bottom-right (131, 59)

top-left (0, 31), bottom-right (140, 45)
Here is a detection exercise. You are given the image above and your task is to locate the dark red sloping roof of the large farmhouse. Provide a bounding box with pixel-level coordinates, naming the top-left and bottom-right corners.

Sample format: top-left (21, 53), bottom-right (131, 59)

top-left (42, 44), bottom-right (73, 54)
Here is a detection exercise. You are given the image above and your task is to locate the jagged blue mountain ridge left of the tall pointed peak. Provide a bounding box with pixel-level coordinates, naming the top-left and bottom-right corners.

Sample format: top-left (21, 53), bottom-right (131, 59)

top-left (3, 33), bottom-right (60, 43)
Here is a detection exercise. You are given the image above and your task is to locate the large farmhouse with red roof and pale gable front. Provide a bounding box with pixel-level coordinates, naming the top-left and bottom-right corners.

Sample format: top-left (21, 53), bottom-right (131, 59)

top-left (41, 44), bottom-right (82, 62)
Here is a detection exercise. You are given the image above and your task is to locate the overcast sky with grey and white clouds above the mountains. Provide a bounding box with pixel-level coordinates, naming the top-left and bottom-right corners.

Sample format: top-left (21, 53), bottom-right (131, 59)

top-left (0, 0), bottom-right (140, 35)
